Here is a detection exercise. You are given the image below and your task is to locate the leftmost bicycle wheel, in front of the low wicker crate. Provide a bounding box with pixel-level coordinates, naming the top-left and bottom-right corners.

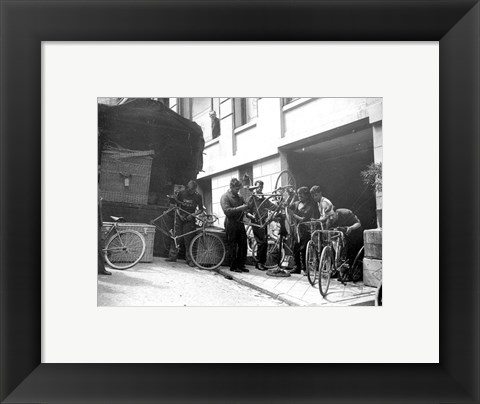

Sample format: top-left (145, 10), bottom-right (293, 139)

top-left (104, 229), bottom-right (145, 269)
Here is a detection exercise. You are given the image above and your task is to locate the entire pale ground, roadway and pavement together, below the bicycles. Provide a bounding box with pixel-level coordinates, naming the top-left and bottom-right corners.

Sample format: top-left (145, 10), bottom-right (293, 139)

top-left (97, 257), bottom-right (376, 306)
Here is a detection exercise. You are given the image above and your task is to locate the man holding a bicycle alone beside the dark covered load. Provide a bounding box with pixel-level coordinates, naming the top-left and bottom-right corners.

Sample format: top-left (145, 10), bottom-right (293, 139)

top-left (166, 180), bottom-right (205, 267)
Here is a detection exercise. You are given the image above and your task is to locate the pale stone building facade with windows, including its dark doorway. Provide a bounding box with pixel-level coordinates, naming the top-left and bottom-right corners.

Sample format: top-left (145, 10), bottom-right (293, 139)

top-left (169, 98), bottom-right (383, 228)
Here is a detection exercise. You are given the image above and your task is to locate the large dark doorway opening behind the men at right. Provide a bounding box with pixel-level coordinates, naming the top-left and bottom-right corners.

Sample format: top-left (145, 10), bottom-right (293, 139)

top-left (287, 128), bottom-right (377, 229)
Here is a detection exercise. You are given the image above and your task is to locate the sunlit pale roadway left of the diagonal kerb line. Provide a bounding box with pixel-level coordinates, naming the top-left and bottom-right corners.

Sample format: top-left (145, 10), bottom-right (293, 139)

top-left (97, 258), bottom-right (288, 306)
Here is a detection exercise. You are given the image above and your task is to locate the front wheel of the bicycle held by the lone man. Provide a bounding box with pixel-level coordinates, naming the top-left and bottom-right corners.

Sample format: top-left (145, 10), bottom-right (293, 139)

top-left (190, 233), bottom-right (225, 269)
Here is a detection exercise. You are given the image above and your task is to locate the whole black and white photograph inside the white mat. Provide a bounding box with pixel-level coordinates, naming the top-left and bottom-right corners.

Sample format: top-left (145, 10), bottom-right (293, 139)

top-left (97, 97), bottom-right (383, 307)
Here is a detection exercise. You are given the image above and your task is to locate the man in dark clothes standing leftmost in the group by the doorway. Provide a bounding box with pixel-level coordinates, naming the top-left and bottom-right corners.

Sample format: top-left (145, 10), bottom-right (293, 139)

top-left (220, 178), bottom-right (249, 272)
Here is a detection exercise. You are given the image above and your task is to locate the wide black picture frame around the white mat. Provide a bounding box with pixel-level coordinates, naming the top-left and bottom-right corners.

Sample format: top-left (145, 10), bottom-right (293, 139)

top-left (0, 0), bottom-right (480, 403)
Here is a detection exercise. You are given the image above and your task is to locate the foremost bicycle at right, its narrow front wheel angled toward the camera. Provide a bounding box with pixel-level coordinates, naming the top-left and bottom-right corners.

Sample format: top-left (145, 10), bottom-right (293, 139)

top-left (312, 228), bottom-right (364, 297)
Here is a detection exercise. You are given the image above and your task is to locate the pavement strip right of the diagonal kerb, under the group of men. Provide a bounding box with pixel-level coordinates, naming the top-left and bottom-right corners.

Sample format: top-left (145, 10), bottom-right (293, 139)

top-left (219, 265), bottom-right (376, 306)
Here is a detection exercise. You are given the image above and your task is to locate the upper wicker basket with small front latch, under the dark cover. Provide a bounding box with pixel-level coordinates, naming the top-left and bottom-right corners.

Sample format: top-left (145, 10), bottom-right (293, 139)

top-left (100, 151), bottom-right (153, 205)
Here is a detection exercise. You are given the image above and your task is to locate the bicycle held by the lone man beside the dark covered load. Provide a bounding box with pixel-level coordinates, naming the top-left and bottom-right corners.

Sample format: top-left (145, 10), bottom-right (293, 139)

top-left (150, 202), bottom-right (226, 270)
